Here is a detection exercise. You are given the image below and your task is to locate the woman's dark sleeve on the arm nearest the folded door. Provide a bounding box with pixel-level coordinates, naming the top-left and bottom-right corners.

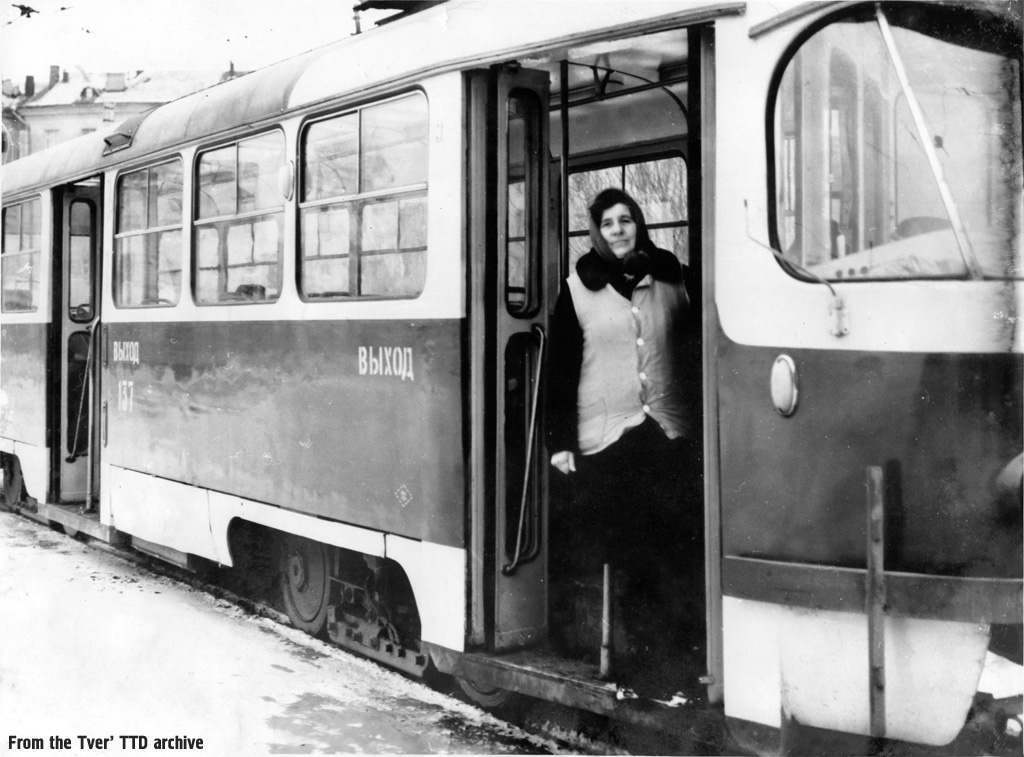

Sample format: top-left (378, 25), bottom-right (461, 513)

top-left (546, 285), bottom-right (583, 454)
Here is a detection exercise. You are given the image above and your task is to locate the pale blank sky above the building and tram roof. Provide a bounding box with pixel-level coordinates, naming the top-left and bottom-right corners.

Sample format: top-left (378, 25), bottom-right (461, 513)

top-left (0, 0), bottom-right (381, 84)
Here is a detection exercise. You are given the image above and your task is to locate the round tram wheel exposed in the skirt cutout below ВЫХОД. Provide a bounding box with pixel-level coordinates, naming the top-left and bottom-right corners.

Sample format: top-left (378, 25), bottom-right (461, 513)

top-left (280, 535), bottom-right (331, 636)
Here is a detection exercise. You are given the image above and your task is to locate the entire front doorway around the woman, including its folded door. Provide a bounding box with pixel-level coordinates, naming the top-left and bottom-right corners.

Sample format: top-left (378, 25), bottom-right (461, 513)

top-left (463, 23), bottom-right (715, 707)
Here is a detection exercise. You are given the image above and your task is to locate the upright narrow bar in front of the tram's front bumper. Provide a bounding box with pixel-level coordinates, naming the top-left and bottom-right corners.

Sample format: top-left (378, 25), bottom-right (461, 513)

top-left (864, 465), bottom-right (886, 739)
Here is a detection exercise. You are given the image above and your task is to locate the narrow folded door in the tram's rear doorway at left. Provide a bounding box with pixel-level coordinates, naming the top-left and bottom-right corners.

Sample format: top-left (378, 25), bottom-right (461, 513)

top-left (51, 179), bottom-right (102, 506)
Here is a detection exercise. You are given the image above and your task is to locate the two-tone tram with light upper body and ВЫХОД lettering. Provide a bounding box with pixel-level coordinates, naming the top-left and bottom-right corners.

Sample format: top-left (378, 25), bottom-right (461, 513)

top-left (0, 0), bottom-right (1024, 752)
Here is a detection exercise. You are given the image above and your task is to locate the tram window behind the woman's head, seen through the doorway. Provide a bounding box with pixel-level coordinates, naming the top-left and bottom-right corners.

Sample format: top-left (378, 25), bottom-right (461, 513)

top-left (569, 156), bottom-right (689, 266)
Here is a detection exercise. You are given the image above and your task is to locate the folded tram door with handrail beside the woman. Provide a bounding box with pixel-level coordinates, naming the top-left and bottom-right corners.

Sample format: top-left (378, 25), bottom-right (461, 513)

top-left (468, 64), bottom-right (557, 650)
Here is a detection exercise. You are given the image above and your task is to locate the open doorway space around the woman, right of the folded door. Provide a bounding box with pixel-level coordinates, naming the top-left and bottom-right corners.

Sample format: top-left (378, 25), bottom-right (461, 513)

top-left (540, 29), bottom-right (708, 701)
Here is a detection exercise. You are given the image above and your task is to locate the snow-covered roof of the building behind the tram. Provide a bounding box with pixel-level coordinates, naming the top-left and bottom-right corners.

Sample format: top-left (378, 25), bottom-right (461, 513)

top-left (22, 71), bottom-right (233, 109)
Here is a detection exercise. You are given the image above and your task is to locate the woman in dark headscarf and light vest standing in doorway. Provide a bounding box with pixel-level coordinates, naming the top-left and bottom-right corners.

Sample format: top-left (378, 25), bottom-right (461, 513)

top-left (548, 188), bottom-right (702, 688)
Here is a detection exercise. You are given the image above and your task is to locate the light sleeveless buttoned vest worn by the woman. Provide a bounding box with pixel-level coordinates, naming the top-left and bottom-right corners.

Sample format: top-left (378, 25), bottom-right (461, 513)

top-left (567, 274), bottom-right (689, 455)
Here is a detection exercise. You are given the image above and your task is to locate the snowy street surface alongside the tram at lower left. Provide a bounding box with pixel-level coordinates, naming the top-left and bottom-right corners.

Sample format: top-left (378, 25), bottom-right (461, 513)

top-left (0, 511), bottom-right (554, 756)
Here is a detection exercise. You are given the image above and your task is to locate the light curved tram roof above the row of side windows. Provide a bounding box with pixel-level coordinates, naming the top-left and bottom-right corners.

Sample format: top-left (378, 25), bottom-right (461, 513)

top-left (3, 0), bottom-right (745, 195)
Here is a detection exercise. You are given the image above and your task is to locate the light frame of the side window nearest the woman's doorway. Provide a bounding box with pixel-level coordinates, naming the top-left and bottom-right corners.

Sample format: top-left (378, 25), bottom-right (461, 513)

top-left (295, 87), bottom-right (430, 303)
